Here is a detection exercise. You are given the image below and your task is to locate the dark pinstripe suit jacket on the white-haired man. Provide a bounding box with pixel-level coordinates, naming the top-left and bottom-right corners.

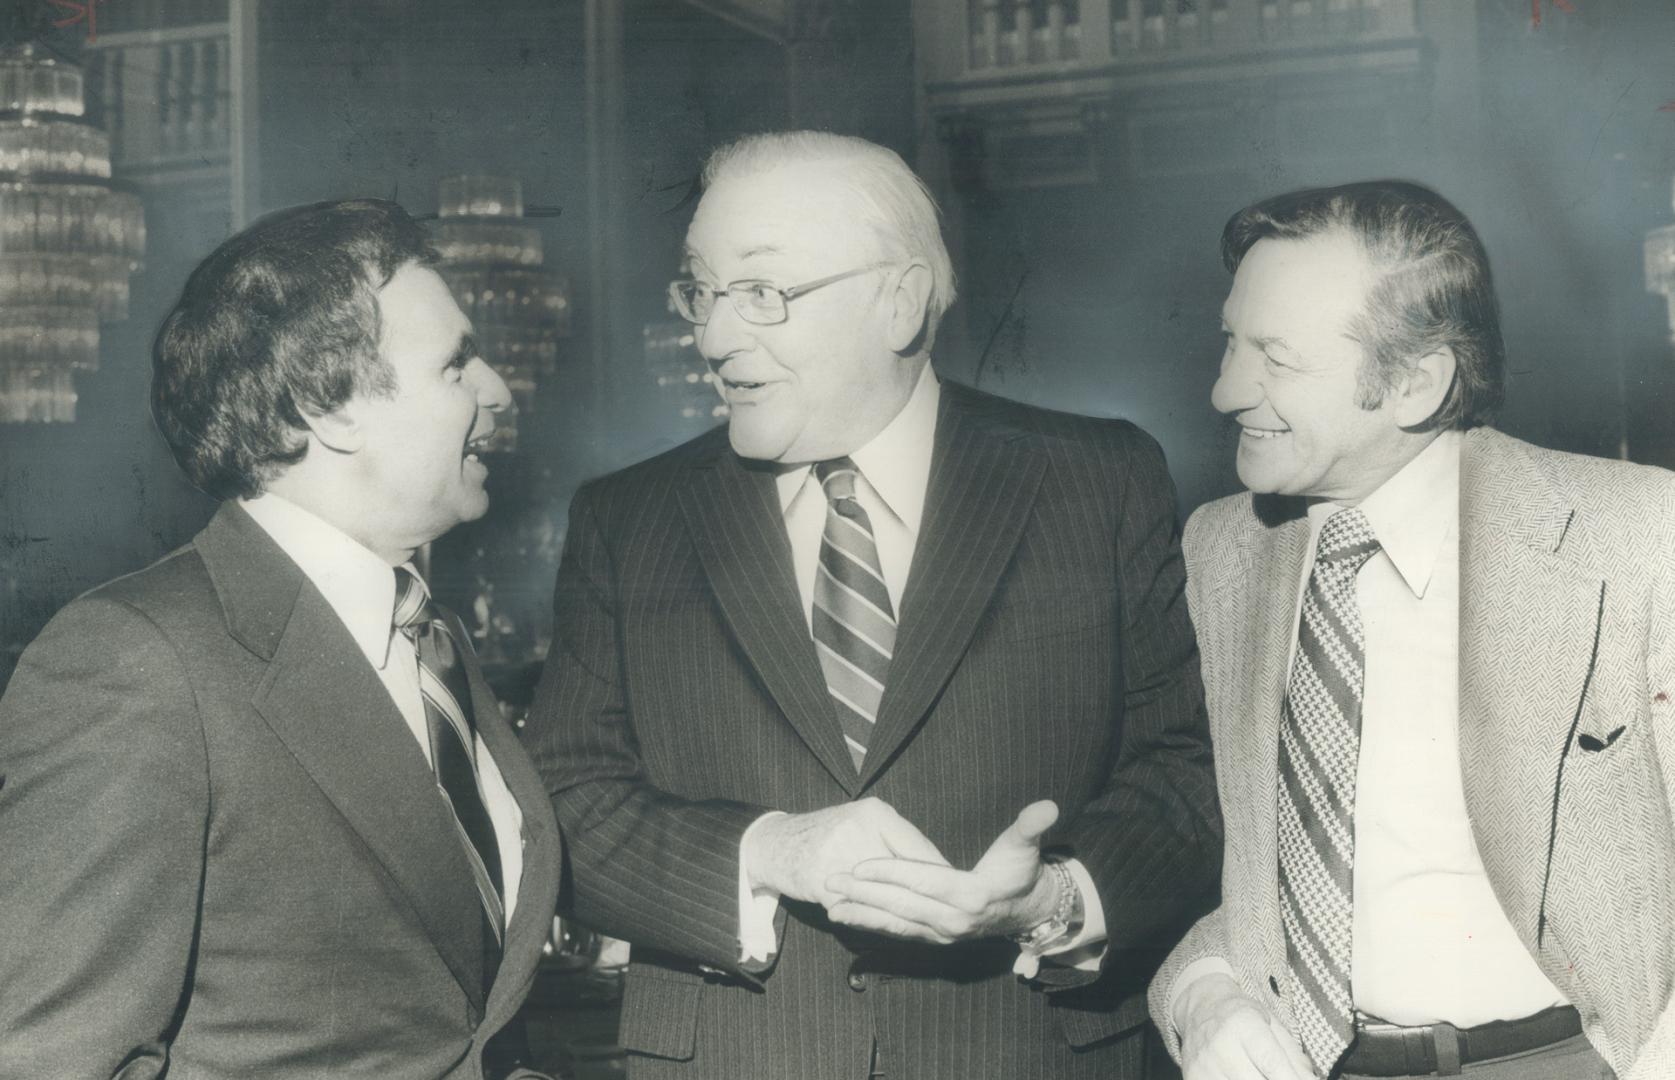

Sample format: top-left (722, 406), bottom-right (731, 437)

top-left (529, 383), bottom-right (1219, 1080)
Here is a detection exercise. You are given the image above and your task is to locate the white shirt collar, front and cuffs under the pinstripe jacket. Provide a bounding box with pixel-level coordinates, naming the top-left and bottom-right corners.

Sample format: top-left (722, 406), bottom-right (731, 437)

top-left (739, 363), bottom-right (1106, 976)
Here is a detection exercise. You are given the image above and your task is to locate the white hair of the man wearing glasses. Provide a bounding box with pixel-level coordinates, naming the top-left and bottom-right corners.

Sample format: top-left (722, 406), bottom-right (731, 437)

top-left (704, 131), bottom-right (955, 348)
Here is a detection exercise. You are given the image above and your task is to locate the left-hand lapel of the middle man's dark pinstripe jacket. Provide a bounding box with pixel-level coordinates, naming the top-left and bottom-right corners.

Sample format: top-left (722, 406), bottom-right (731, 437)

top-left (678, 447), bottom-right (859, 795)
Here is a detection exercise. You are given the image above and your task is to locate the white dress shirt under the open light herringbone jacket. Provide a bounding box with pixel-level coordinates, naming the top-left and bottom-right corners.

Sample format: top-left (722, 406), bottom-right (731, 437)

top-left (1171, 432), bottom-right (1564, 1028)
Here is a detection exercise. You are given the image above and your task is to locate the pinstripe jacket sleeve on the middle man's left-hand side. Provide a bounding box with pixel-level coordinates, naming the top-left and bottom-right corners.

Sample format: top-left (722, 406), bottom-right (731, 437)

top-left (526, 487), bottom-right (770, 978)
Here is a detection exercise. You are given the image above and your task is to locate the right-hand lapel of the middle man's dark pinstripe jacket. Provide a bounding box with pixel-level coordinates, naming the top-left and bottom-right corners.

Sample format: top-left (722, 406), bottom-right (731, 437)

top-left (861, 383), bottom-right (1047, 784)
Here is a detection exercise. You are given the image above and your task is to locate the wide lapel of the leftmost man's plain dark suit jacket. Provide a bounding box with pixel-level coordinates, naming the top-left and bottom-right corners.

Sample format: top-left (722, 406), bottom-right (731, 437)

top-left (196, 504), bottom-right (482, 1001)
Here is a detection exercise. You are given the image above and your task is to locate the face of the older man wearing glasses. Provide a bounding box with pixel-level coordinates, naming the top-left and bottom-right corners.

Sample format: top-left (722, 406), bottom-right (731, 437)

top-left (687, 162), bottom-right (923, 464)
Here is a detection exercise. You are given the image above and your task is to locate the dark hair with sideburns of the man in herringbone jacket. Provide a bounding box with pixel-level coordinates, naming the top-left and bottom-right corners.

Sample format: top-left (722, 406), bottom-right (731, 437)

top-left (1221, 181), bottom-right (1506, 430)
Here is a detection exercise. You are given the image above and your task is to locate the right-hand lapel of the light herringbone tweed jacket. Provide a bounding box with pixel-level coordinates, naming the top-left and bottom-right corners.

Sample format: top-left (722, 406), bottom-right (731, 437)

top-left (1459, 430), bottom-right (1603, 949)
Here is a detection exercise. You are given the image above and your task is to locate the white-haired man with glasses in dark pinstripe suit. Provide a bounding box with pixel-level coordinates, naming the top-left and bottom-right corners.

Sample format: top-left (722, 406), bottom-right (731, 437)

top-left (529, 132), bottom-right (1221, 1080)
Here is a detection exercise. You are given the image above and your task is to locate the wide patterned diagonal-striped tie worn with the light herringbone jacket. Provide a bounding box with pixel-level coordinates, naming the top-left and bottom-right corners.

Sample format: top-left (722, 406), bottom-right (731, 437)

top-left (1278, 509), bottom-right (1379, 1075)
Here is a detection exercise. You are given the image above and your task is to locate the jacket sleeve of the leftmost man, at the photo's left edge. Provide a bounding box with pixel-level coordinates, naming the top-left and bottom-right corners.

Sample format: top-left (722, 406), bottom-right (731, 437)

top-left (0, 598), bottom-right (209, 1080)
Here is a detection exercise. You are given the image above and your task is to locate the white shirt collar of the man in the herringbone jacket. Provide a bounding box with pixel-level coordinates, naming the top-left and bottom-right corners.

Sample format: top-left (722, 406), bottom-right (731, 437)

top-left (1308, 430), bottom-right (1461, 599)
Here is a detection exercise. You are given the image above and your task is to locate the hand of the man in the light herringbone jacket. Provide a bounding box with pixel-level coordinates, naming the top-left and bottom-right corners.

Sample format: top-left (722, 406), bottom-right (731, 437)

top-left (1174, 973), bottom-right (1315, 1080)
